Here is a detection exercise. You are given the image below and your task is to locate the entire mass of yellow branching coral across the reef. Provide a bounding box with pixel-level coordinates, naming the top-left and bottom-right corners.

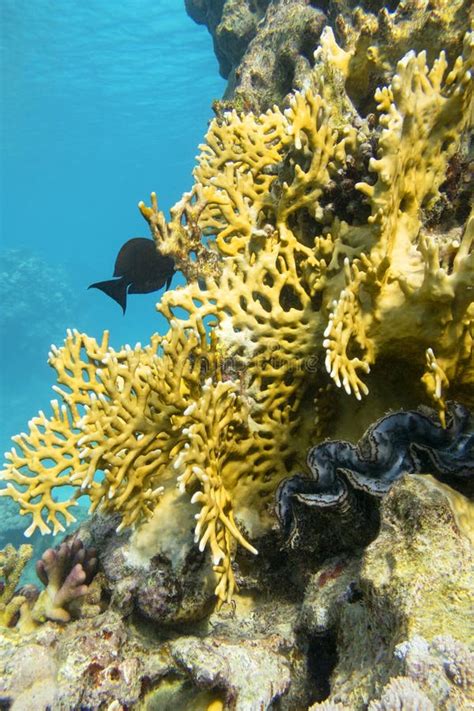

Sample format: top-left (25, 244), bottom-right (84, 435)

top-left (0, 33), bottom-right (474, 601)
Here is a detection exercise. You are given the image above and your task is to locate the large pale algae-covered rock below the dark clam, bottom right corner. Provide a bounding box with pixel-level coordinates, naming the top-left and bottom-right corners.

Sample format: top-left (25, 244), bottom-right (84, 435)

top-left (298, 477), bottom-right (474, 711)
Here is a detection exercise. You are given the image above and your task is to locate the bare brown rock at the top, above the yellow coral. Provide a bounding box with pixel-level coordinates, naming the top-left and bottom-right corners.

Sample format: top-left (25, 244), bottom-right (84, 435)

top-left (186, 0), bottom-right (326, 111)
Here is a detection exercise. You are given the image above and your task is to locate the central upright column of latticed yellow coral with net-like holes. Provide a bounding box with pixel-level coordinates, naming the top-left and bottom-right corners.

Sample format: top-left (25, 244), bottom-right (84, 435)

top-left (142, 87), bottom-right (347, 524)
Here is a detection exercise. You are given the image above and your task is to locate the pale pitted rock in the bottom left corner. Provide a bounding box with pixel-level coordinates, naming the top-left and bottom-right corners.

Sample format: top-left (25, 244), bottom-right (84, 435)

top-left (0, 612), bottom-right (169, 710)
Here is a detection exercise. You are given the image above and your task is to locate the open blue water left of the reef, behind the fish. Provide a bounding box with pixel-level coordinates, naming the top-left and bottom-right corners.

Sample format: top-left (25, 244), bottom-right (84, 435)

top-left (0, 0), bottom-right (224, 452)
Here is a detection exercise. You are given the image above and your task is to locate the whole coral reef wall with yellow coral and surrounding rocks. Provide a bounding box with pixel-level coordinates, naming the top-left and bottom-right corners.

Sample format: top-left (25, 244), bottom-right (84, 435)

top-left (0, 0), bottom-right (474, 711)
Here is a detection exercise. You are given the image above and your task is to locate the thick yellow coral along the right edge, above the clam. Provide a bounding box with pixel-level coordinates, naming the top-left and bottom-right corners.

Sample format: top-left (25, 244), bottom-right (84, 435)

top-left (326, 34), bottom-right (473, 412)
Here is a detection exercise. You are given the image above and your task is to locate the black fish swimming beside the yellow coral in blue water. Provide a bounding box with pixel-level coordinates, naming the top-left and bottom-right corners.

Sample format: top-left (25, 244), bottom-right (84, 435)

top-left (88, 237), bottom-right (175, 313)
